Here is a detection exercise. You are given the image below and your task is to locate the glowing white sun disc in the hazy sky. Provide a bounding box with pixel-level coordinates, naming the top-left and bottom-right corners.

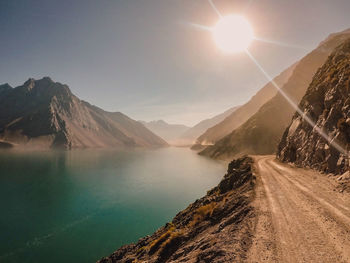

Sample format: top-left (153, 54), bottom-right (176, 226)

top-left (212, 15), bottom-right (254, 53)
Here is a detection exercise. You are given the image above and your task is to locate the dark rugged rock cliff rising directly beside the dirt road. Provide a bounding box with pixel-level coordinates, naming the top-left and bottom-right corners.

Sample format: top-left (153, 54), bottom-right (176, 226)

top-left (278, 38), bottom-right (350, 173)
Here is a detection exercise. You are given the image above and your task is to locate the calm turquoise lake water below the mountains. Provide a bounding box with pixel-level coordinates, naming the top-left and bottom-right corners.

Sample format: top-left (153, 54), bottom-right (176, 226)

top-left (0, 148), bottom-right (226, 262)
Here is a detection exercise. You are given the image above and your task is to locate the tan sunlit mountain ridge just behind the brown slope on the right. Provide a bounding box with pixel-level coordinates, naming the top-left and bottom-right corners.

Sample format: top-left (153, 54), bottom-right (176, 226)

top-left (196, 64), bottom-right (296, 145)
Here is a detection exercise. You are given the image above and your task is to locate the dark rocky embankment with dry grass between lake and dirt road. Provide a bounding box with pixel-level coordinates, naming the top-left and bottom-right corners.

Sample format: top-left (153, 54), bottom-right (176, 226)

top-left (99, 157), bottom-right (256, 263)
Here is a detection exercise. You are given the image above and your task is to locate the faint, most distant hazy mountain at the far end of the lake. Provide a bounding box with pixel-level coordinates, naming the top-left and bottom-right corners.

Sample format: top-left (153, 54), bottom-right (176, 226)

top-left (140, 120), bottom-right (190, 144)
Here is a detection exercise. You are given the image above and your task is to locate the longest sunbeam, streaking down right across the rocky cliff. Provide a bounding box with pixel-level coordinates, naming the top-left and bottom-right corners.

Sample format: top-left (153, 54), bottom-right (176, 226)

top-left (246, 49), bottom-right (349, 157)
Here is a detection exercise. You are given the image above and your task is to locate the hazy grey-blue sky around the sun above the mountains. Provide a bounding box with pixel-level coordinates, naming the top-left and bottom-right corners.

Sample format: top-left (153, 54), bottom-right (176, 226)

top-left (0, 0), bottom-right (350, 125)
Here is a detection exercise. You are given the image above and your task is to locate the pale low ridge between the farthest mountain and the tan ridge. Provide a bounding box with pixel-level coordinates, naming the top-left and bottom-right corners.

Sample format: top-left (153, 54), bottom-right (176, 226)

top-left (177, 106), bottom-right (239, 145)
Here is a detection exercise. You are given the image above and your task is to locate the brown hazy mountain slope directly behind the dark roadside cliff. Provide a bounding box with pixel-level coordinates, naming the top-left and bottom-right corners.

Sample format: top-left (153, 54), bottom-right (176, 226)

top-left (200, 29), bottom-right (350, 158)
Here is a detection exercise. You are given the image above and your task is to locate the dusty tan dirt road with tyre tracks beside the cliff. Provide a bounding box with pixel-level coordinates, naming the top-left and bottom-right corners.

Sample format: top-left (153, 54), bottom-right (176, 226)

top-left (248, 156), bottom-right (350, 263)
